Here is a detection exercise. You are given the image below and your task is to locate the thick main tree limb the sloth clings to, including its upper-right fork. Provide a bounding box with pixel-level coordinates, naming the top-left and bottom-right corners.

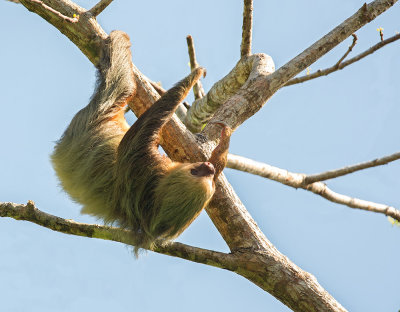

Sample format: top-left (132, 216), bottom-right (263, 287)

top-left (7, 0), bottom-right (396, 312)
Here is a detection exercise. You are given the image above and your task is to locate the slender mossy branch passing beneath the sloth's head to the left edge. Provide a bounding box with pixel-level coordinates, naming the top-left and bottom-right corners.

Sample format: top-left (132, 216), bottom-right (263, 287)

top-left (0, 201), bottom-right (238, 270)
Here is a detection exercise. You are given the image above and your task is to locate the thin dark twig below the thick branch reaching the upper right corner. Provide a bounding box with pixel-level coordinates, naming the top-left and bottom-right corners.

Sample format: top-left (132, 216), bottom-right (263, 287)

top-left (285, 34), bottom-right (400, 87)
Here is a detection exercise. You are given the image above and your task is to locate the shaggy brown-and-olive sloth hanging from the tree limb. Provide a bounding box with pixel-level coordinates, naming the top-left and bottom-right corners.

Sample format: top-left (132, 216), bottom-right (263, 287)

top-left (52, 31), bottom-right (231, 248)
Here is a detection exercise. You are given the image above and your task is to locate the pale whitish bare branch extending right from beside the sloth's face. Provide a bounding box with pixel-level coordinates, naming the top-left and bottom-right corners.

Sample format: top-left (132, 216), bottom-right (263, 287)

top-left (227, 154), bottom-right (400, 221)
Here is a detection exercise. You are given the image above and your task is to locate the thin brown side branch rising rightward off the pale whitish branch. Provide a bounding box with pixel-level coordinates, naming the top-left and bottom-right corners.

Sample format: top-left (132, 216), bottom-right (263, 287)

top-left (304, 152), bottom-right (400, 184)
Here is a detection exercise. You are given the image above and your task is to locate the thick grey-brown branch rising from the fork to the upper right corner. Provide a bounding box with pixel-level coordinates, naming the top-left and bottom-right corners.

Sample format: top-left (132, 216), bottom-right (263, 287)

top-left (203, 0), bottom-right (397, 140)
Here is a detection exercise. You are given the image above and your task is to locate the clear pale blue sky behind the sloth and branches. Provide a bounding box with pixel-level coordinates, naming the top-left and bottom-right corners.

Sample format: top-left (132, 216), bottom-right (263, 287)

top-left (0, 0), bottom-right (400, 312)
